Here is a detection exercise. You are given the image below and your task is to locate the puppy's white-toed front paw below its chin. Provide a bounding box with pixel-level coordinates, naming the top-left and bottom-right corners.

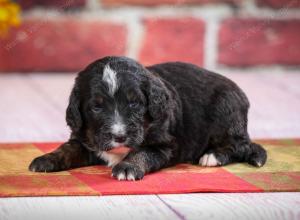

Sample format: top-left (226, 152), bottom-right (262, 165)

top-left (112, 162), bottom-right (145, 181)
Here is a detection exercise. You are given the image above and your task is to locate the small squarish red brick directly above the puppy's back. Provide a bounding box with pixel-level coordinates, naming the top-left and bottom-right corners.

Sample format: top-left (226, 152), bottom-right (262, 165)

top-left (139, 18), bottom-right (205, 65)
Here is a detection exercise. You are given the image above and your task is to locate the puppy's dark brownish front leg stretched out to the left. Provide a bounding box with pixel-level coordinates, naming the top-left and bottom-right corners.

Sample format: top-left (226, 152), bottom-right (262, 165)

top-left (29, 140), bottom-right (99, 172)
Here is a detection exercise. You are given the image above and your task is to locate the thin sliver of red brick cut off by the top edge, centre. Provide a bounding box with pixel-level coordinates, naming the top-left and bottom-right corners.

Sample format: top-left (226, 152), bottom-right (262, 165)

top-left (101, 0), bottom-right (242, 7)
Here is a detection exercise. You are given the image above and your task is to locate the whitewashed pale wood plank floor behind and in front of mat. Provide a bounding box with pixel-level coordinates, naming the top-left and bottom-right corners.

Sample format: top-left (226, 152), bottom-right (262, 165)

top-left (0, 73), bottom-right (300, 220)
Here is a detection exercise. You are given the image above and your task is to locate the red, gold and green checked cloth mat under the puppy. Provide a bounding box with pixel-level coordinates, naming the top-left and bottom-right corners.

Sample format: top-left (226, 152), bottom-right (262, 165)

top-left (0, 139), bottom-right (300, 197)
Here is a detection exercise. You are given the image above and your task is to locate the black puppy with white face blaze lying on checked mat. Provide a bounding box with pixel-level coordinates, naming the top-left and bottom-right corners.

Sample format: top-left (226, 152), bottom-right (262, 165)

top-left (29, 57), bottom-right (267, 180)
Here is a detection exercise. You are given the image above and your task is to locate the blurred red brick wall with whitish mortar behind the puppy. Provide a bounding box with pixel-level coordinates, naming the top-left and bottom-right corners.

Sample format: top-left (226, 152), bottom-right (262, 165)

top-left (0, 0), bottom-right (300, 72)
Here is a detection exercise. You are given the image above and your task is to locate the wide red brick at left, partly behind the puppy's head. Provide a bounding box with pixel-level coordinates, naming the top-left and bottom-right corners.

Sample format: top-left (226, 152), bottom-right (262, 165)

top-left (0, 18), bottom-right (126, 72)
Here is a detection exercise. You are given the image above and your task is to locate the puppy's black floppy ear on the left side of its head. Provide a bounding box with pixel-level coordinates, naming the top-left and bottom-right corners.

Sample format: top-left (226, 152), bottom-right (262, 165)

top-left (66, 84), bottom-right (82, 132)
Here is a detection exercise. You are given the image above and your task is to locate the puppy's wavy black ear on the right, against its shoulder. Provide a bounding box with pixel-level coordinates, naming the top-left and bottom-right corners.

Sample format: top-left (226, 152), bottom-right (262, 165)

top-left (145, 74), bottom-right (174, 143)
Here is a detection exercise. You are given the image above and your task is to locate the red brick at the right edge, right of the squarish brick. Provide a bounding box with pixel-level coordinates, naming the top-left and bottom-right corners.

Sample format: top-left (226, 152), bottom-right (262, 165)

top-left (219, 19), bottom-right (300, 66)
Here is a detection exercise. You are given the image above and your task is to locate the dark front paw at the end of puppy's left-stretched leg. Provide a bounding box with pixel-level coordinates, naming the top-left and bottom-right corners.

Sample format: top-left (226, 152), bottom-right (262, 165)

top-left (29, 155), bottom-right (59, 172)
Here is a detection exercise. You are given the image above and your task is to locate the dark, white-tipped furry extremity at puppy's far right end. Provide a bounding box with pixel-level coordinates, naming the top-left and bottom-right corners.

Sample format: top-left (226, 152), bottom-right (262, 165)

top-left (247, 142), bottom-right (267, 167)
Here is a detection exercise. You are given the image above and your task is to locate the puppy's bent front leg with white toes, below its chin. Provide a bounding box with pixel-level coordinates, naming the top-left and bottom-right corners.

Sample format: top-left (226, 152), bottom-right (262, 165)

top-left (112, 148), bottom-right (172, 180)
